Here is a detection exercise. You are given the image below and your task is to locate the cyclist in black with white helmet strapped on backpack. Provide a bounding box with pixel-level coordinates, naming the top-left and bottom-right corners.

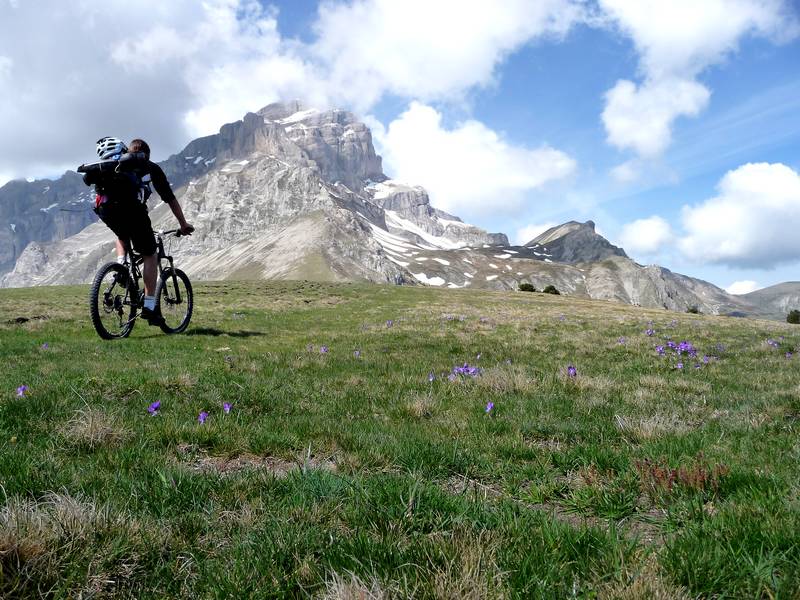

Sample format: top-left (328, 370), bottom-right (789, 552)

top-left (78, 137), bottom-right (194, 325)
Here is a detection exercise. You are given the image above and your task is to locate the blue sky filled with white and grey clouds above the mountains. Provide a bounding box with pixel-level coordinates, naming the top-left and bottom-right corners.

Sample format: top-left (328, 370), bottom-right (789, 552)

top-left (0, 0), bottom-right (800, 291)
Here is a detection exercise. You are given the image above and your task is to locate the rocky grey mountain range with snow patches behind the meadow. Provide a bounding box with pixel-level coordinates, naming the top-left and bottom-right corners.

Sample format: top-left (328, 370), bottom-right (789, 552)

top-left (0, 101), bottom-right (796, 318)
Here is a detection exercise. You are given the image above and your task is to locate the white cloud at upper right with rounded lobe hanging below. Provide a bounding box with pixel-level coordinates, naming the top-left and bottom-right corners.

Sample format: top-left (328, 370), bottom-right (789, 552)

top-left (599, 0), bottom-right (800, 157)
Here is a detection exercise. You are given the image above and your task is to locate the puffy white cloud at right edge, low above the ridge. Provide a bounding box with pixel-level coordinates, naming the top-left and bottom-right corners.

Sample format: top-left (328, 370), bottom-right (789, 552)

top-left (681, 163), bottom-right (800, 268)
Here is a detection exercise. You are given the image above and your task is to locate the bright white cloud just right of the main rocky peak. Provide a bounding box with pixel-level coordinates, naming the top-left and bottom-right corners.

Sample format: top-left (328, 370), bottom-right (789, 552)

top-left (373, 102), bottom-right (575, 217)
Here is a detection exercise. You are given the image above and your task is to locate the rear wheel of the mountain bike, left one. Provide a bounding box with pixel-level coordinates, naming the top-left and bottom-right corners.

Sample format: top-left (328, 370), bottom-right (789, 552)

top-left (89, 263), bottom-right (137, 340)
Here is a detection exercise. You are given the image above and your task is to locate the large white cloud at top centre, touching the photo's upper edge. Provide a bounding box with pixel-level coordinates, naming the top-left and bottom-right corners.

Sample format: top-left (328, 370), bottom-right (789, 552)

top-left (313, 0), bottom-right (582, 108)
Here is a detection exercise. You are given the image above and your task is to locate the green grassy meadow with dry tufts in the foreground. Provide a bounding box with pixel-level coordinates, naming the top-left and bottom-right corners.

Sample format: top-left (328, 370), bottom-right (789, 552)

top-left (0, 282), bottom-right (800, 598)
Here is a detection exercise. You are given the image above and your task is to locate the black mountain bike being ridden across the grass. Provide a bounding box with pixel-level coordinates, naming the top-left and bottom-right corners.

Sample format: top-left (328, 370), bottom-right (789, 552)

top-left (89, 229), bottom-right (194, 340)
